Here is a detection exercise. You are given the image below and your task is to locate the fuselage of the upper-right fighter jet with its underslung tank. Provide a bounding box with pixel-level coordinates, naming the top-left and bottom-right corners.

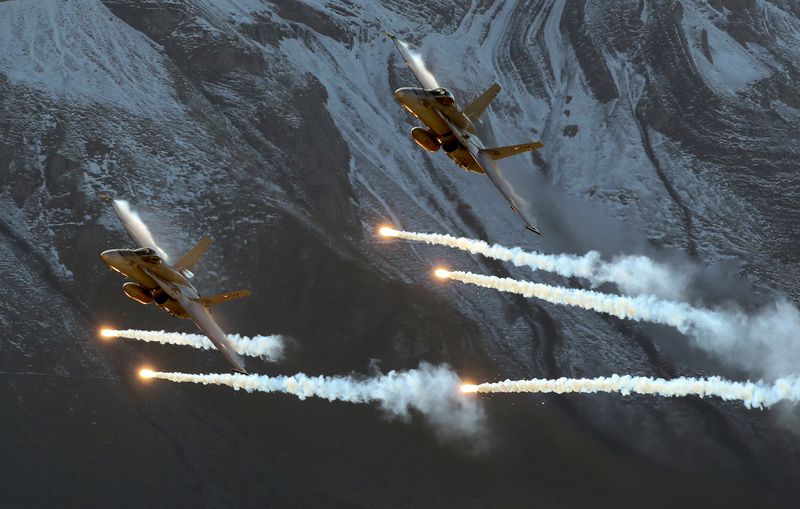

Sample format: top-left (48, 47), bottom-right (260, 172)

top-left (394, 87), bottom-right (484, 173)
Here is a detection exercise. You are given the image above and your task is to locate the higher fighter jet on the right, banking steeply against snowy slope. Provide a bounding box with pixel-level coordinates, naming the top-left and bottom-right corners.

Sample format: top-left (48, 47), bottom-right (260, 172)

top-left (386, 32), bottom-right (544, 234)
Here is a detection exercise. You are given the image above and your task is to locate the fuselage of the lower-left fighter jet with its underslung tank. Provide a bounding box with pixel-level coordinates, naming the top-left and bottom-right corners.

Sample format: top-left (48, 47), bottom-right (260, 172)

top-left (100, 248), bottom-right (194, 318)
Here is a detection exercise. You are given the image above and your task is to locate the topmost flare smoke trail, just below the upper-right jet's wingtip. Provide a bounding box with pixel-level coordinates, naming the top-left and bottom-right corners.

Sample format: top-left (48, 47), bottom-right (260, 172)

top-left (379, 227), bottom-right (689, 299)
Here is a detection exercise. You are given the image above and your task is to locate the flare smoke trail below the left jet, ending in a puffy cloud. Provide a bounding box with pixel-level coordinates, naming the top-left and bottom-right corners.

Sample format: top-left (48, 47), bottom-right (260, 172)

top-left (141, 362), bottom-right (486, 443)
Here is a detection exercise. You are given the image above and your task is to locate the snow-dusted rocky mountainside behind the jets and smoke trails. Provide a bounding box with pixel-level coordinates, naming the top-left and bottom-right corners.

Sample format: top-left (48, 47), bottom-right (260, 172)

top-left (0, 0), bottom-right (800, 506)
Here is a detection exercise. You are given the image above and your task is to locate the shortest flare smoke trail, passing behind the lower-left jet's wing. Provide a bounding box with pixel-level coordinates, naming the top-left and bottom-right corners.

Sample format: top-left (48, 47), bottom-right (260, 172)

top-left (101, 329), bottom-right (284, 362)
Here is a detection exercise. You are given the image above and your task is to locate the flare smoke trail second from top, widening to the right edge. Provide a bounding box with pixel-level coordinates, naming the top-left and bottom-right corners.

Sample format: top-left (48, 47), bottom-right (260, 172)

top-left (436, 269), bottom-right (800, 377)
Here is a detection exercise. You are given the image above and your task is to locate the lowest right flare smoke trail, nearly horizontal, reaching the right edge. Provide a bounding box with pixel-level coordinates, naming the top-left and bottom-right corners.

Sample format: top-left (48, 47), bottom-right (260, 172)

top-left (461, 375), bottom-right (800, 408)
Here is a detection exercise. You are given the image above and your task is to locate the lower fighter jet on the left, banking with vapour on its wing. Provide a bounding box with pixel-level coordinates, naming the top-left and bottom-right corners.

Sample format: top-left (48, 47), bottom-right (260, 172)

top-left (100, 200), bottom-right (250, 374)
